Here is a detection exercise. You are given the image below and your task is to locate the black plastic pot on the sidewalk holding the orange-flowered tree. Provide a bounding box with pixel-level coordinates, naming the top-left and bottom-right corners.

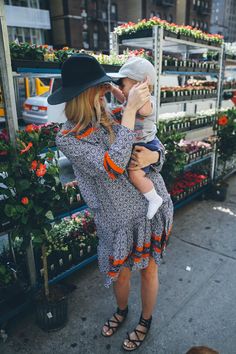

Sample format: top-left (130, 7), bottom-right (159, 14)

top-left (36, 296), bottom-right (68, 332)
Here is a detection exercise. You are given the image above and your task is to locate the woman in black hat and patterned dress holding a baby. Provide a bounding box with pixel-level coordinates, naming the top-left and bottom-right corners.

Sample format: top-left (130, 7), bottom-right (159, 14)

top-left (48, 54), bottom-right (173, 351)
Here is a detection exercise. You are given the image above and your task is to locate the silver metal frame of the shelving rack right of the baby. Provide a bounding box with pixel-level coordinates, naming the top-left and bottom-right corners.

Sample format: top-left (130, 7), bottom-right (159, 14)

top-left (110, 26), bottom-right (224, 188)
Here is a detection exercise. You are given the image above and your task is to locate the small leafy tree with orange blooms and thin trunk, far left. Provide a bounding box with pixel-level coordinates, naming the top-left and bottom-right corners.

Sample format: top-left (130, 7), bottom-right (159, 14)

top-left (0, 125), bottom-right (71, 297)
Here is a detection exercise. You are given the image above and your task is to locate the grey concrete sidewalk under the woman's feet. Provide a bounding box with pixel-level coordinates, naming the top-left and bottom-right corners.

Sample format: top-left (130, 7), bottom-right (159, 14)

top-left (0, 175), bottom-right (236, 354)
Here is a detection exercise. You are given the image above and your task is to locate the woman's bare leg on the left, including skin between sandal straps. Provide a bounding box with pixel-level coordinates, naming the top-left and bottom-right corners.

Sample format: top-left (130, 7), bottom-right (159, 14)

top-left (102, 267), bottom-right (131, 336)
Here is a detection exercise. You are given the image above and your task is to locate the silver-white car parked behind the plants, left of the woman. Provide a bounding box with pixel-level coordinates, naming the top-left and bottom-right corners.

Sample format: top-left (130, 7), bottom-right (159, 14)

top-left (22, 79), bottom-right (66, 124)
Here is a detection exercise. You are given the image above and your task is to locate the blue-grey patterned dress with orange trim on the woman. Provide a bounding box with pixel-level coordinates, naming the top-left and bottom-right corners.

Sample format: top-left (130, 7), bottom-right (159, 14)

top-left (56, 122), bottom-right (173, 287)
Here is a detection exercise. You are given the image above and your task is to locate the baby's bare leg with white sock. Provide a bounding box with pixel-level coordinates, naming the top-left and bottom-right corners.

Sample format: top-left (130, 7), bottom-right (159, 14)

top-left (129, 169), bottom-right (163, 219)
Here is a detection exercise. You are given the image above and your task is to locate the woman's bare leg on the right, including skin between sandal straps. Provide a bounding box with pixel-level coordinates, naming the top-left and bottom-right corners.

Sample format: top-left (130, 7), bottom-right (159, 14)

top-left (124, 257), bottom-right (159, 348)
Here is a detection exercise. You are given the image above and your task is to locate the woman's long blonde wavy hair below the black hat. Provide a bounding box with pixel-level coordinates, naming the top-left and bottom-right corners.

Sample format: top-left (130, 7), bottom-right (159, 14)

top-left (65, 85), bottom-right (115, 141)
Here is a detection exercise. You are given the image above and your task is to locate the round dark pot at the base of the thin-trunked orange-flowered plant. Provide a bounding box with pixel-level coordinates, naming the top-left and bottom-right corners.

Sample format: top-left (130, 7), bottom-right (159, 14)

top-left (35, 286), bottom-right (68, 332)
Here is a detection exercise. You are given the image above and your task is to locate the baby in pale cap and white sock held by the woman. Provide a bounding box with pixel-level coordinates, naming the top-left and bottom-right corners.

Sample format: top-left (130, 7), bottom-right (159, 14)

top-left (111, 57), bottom-right (162, 219)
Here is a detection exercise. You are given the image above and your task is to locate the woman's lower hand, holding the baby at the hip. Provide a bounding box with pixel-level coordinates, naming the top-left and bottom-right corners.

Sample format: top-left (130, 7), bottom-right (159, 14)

top-left (128, 145), bottom-right (160, 171)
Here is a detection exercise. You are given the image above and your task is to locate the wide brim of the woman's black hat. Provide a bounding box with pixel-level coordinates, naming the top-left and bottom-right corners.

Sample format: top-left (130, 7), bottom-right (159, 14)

top-left (47, 75), bottom-right (113, 105)
